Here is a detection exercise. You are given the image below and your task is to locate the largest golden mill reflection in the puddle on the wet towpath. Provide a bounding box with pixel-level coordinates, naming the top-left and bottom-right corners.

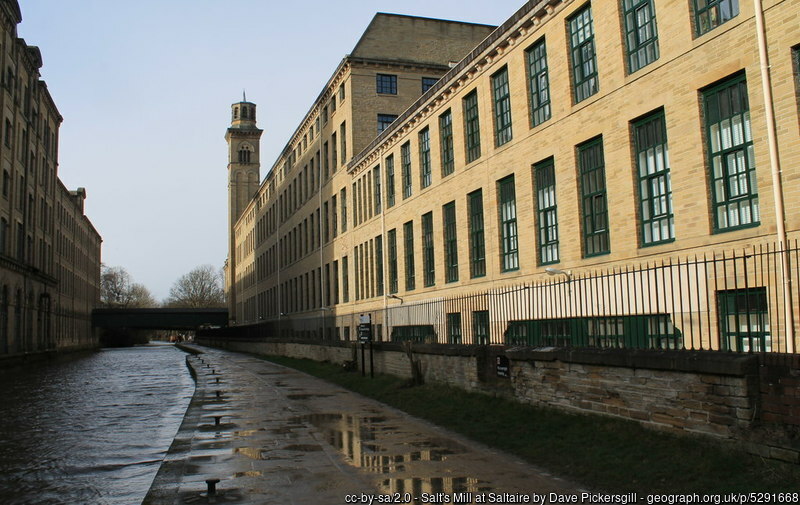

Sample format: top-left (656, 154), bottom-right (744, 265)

top-left (287, 414), bottom-right (484, 503)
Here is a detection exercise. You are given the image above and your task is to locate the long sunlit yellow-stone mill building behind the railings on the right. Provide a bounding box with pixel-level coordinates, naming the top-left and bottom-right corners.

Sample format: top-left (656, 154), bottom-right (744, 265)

top-left (223, 0), bottom-right (800, 351)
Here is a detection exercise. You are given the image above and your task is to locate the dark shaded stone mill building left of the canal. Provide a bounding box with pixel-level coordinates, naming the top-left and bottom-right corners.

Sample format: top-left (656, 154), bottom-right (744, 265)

top-left (0, 0), bottom-right (102, 357)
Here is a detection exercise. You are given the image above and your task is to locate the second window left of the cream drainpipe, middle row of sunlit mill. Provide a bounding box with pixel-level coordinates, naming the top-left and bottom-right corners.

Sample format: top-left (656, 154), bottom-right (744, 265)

top-left (633, 111), bottom-right (675, 246)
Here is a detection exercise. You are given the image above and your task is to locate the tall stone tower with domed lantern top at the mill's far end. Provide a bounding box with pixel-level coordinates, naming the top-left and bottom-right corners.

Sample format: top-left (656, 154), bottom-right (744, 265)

top-left (225, 96), bottom-right (263, 323)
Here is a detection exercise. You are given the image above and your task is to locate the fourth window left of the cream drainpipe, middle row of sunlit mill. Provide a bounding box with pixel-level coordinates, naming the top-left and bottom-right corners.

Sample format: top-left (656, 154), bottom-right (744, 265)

top-left (533, 158), bottom-right (559, 265)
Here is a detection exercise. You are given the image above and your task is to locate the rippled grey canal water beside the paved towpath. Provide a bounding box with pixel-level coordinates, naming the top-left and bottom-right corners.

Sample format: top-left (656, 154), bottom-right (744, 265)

top-left (0, 344), bottom-right (194, 505)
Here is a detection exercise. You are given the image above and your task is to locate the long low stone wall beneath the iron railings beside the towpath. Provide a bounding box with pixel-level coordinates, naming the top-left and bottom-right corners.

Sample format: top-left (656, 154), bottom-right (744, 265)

top-left (199, 338), bottom-right (800, 463)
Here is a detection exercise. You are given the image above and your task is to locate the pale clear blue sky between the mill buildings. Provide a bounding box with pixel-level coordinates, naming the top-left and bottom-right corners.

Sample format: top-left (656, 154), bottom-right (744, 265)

top-left (19, 0), bottom-right (524, 299)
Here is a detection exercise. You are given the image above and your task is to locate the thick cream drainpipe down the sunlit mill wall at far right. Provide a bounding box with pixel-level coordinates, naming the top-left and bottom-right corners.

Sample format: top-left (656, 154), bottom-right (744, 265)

top-left (753, 0), bottom-right (795, 353)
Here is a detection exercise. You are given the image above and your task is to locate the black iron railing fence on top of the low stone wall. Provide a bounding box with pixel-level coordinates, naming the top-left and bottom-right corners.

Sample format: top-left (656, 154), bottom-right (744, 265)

top-left (208, 240), bottom-right (800, 353)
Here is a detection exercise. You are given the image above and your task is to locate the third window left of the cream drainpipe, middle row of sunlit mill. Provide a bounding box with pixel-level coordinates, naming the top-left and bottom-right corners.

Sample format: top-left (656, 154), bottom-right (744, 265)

top-left (578, 137), bottom-right (611, 257)
